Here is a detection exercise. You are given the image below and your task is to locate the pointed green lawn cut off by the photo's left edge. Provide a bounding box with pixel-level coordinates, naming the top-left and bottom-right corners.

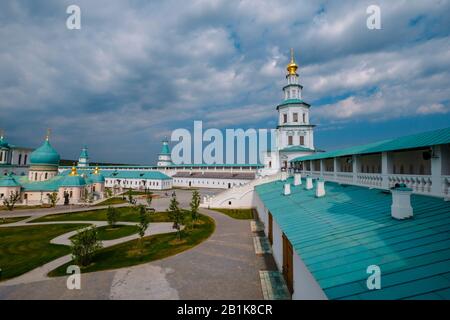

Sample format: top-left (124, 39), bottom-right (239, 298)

top-left (0, 224), bottom-right (88, 281)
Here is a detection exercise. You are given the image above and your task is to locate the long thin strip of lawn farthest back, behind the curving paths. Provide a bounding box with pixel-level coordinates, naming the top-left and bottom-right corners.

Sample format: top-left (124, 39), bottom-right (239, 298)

top-left (30, 207), bottom-right (190, 223)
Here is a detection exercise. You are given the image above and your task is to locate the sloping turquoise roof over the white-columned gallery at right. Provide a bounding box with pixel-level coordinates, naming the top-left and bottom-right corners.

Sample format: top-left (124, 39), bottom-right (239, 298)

top-left (291, 127), bottom-right (450, 162)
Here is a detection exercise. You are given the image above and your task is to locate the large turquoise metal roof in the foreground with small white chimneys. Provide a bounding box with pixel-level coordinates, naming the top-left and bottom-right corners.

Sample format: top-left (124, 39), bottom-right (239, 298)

top-left (255, 179), bottom-right (450, 299)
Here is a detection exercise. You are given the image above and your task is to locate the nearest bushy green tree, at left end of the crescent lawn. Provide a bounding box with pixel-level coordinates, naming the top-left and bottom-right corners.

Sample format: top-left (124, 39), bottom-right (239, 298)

top-left (70, 227), bottom-right (102, 267)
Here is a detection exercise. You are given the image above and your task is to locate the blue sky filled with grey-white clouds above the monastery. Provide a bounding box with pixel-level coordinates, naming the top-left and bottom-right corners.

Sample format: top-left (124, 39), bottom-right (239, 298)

top-left (0, 0), bottom-right (450, 164)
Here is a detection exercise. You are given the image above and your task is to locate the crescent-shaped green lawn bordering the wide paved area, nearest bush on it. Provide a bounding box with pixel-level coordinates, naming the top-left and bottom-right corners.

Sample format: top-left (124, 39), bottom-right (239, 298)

top-left (49, 215), bottom-right (215, 277)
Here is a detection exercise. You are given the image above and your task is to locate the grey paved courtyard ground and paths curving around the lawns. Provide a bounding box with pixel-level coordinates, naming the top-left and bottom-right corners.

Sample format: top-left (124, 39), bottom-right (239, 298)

top-left (0, 190), bottom-right (276, 299)
